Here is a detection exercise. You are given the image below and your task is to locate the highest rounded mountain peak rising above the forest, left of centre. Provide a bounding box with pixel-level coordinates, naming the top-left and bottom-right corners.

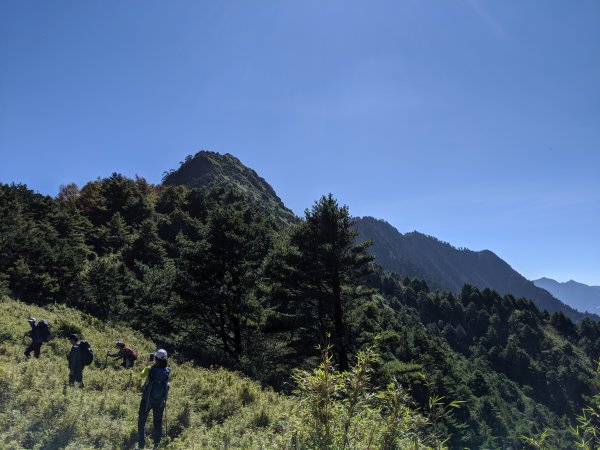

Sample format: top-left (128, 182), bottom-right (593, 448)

top-left (163, 150), bottom-right (298, 226)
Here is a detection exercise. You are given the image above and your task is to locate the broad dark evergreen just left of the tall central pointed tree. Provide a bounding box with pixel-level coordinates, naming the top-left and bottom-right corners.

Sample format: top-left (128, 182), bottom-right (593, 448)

top-left (177, 203), bottom-right (272, 361)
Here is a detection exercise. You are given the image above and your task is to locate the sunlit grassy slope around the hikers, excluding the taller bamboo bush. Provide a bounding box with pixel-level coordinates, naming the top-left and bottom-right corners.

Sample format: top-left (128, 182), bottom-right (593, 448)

top-left (0, 298), bottom-right (292, 450)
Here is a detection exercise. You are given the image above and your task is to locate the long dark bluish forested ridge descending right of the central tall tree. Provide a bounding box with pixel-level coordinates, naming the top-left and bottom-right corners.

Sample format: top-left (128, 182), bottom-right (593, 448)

top-left (356, 217), bottom-right (599, 320)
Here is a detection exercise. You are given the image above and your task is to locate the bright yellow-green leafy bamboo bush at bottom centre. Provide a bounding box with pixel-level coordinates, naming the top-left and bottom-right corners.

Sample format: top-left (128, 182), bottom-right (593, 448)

top-left (291, 346), bottom-right (460, 450)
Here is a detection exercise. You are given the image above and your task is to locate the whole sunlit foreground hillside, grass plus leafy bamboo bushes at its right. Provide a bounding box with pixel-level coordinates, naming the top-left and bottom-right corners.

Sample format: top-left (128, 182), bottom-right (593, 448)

top-left (0, 297), bottom-right (447, 450)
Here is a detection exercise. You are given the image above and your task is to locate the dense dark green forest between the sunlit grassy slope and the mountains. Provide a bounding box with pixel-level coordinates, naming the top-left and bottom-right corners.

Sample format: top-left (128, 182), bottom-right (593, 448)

top-left (0, 158), bottom-right (600, 449)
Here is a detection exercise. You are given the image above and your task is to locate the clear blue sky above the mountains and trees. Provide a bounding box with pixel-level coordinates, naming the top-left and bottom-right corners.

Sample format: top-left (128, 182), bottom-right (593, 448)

top-left (0, 0), bottom-right (600, 285)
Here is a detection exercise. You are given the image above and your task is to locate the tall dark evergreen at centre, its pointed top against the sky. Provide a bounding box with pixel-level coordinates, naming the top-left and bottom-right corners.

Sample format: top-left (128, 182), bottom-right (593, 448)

top-left (271, 194), bottom-right (372, 370)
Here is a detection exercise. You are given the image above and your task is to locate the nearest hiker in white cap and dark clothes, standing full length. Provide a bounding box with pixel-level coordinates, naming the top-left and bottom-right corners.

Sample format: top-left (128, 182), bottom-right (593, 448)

top-left (138, 349), bottom-right (171, 449)
